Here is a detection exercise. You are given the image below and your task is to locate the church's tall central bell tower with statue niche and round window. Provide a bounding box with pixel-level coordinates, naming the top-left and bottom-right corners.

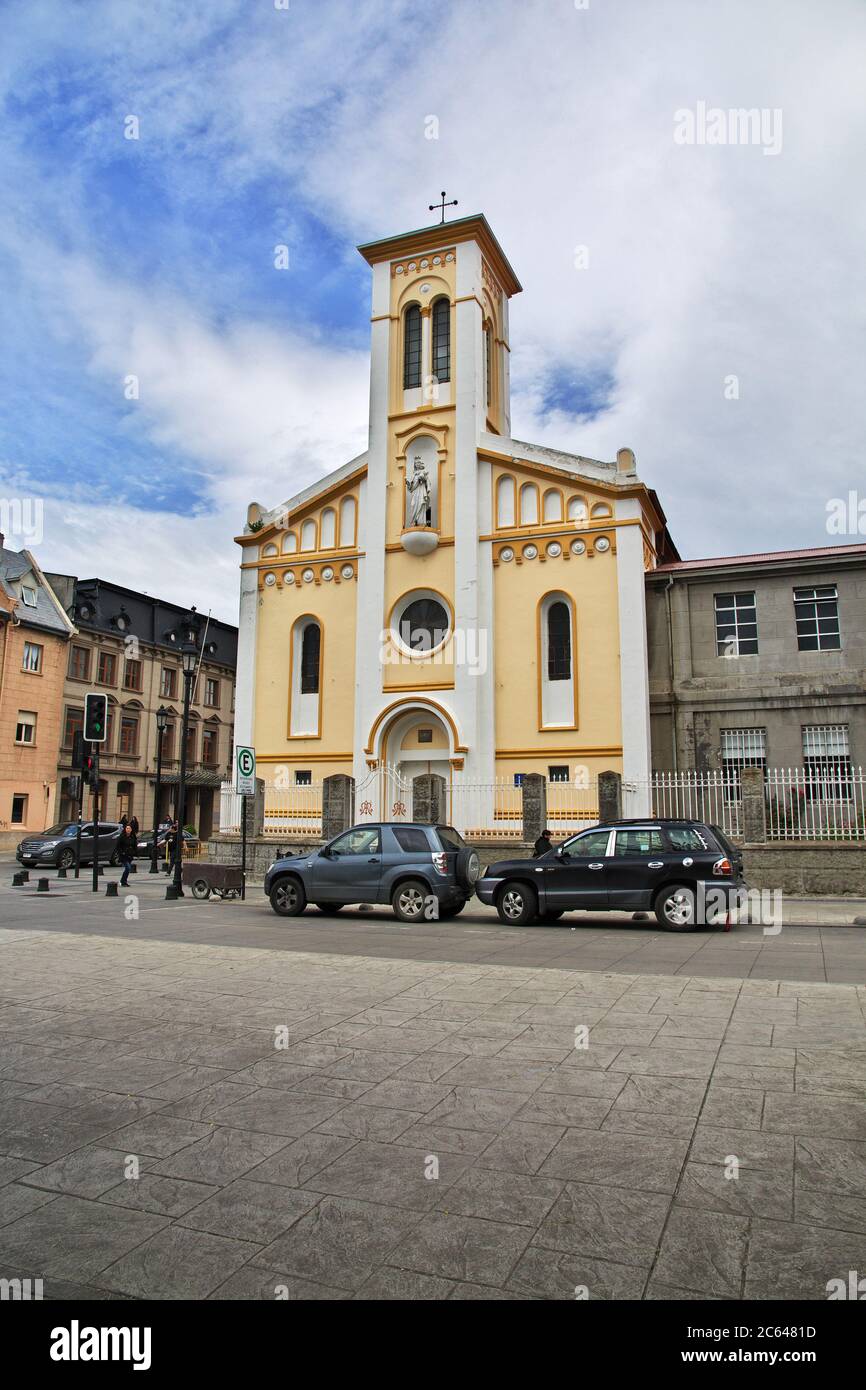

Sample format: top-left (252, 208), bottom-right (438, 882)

top-left (354, 207), bottom-right (521, 780)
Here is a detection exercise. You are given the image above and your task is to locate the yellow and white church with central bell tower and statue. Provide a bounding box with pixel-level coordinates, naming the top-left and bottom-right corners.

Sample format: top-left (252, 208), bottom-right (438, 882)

top-left (235, 215), bottom-right (678, 819)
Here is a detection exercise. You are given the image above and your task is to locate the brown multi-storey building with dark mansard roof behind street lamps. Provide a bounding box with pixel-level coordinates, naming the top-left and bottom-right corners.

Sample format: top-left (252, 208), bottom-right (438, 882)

top-left (51, 575), bottom-right (238, 838)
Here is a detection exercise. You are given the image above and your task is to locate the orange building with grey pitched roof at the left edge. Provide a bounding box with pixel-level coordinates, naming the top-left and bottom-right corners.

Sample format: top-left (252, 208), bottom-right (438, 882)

top-left (0, 535), bottom-right (75, 849)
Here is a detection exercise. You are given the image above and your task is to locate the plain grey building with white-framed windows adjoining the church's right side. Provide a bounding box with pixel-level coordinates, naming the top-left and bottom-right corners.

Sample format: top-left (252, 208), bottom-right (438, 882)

top-left (645, 545), bottom-right (866, 778)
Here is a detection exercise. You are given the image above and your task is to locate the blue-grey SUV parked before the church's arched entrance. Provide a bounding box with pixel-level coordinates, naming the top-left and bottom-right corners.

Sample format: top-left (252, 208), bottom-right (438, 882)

top-left (264, 821), bottom-right (481, 922)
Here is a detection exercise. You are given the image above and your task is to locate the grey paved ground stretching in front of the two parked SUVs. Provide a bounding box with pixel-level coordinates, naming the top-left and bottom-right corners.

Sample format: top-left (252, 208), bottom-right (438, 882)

top-left (0, 873), bottom-right (866, 1300)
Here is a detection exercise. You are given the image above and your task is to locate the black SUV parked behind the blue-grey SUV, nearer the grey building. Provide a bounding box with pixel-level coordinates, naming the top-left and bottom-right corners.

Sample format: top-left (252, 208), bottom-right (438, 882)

top-left (475, 817), bottom-right (745, 931)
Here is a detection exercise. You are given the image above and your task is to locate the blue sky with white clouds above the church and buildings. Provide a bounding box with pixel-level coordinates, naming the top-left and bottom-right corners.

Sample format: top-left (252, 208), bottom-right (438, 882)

top-left (0, 0), bottom-right (866, 620)
